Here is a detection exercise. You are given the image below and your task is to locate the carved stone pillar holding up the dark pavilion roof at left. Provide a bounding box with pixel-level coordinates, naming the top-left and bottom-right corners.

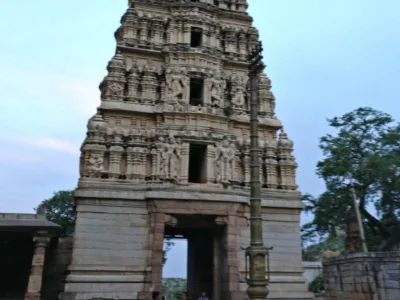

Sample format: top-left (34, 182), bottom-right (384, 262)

top-left (25, 233), bottom-right (50, 300)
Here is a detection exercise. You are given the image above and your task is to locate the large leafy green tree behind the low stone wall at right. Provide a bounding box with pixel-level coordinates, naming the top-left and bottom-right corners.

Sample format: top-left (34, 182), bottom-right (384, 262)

top-left (302, 107), bottom-right (400, 250)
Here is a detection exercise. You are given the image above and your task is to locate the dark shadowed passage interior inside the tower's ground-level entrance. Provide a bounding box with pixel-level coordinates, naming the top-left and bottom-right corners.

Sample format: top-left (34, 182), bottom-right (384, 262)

top-left (164, 215), bottom-right (226, 300)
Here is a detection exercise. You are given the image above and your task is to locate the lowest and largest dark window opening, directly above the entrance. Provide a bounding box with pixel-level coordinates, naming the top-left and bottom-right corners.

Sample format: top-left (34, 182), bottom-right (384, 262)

top-left (188, 144), bottom-right (207, 183)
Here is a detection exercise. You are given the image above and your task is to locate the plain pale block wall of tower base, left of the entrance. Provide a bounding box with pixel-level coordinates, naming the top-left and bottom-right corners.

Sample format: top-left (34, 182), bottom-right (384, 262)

top-left (62, 198), bottom-right (151, 299)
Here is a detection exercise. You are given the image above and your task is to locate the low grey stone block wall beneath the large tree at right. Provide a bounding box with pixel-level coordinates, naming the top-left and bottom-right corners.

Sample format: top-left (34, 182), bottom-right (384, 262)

top-left (323, 252), bottom-right (400, 300)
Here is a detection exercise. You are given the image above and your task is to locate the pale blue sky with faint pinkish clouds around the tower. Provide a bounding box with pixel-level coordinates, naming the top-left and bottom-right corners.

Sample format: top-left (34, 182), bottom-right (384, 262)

top-left (0, 0), bottom-right (400, 277)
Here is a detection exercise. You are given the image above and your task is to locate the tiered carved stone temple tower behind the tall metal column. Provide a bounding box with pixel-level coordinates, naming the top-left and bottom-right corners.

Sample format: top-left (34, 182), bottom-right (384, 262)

top-left (61, 0), bottom-right (313, 300)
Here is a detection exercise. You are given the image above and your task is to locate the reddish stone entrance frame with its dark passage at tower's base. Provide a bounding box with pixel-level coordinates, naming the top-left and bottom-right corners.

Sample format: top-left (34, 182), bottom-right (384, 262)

top-left (146, 200), bottom-right (242, 300)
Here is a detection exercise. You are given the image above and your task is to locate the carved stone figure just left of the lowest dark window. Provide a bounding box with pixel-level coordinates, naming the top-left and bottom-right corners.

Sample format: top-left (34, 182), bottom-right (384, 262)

top-left (160, 134), bottom-right (182, 180)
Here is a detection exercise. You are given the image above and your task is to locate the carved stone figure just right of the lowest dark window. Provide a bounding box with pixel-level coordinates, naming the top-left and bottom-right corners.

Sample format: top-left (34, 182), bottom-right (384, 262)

top-left (214, 138), bottom-right (236, 184)
